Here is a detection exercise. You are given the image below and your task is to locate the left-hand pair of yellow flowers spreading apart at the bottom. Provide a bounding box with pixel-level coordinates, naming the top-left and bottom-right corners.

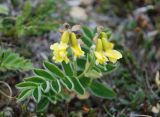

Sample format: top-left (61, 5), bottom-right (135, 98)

top-left (50, 30), bottom-right (84, 63)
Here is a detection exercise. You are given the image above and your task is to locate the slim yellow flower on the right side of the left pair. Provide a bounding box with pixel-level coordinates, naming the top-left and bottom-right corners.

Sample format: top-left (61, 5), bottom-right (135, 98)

top-left (71, 33), bottom-right (84, 58)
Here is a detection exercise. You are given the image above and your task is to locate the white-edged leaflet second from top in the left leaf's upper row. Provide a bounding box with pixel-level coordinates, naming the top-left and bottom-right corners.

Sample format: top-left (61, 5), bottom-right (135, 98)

top-left (34, 69), bottom-right (55, 80)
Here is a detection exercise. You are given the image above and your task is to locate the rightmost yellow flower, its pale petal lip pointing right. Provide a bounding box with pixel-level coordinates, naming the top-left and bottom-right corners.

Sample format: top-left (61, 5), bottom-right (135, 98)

top-left (102, 38), bottom-right (122, 63)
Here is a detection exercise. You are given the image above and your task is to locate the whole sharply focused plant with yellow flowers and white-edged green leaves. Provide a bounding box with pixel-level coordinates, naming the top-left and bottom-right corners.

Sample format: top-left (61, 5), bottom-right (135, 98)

top-left (16, 24), bottom-right (122, 111)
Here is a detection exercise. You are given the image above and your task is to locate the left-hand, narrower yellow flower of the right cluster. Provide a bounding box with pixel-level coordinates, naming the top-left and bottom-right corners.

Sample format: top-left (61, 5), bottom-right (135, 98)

top-left (94, 39), bottom-right (108, 64)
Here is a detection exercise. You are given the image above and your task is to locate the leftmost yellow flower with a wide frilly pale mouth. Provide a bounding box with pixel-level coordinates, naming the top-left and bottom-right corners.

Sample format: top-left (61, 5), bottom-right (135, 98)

top-left (50, 31), bottom-right (69, 63)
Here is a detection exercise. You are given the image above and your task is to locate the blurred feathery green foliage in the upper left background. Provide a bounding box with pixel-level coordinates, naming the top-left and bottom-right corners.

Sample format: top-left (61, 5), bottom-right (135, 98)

top-left (0, 0), bottom-right (58, 37)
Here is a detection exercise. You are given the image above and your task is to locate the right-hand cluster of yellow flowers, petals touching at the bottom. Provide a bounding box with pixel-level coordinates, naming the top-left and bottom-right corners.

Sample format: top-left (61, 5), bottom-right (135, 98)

top-left (94, 32), bottom-right (122, 64)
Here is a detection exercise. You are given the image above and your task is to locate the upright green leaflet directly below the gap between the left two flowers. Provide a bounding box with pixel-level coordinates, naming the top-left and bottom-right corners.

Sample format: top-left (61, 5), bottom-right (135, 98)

top-left (62, 62), bottom-right (73, 76)
